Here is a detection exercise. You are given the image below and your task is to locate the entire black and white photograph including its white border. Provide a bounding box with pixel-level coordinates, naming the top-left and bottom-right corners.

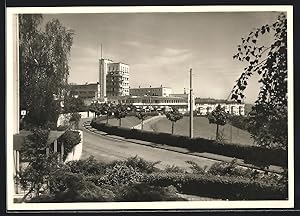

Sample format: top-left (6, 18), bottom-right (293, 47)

top-left (6, 6), bottom-right (294, 210)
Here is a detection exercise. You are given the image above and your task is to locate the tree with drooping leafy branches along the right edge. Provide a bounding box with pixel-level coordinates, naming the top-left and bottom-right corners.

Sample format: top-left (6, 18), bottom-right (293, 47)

top-left (231, 13), bottom-right (288, 149)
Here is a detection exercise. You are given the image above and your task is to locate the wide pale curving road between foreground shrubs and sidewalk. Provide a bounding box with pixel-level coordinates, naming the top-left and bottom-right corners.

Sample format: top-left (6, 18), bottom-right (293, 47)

top-left (80, 118), bottom-right (216, 169)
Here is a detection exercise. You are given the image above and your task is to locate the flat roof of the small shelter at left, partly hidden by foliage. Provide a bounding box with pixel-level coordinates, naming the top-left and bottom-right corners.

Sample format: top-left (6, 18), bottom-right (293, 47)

top-left (13, 131), bottom-right (65, 150)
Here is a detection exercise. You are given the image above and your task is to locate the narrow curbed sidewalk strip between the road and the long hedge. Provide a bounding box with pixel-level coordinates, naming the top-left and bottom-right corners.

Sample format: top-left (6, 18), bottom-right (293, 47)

top-left (83, 118), bottom-right (282, 174)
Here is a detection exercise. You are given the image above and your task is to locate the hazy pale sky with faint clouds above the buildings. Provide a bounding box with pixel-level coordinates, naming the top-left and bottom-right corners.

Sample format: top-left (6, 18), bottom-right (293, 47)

top-left (44, 12), bottom-right (278, 103)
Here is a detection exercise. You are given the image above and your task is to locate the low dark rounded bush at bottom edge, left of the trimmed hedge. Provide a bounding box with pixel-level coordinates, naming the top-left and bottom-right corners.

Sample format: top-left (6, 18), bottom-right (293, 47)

top-left (115, 183), bottom-right (186, 202)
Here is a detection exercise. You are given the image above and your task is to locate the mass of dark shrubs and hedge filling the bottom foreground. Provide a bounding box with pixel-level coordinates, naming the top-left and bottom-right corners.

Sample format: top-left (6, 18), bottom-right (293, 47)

top-left (29, 157), bottom-right (287, 202)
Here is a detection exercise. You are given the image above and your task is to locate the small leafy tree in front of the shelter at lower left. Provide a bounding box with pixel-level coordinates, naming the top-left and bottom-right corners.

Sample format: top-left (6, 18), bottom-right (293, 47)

top-left (17, 129), bottom-right (60, 201)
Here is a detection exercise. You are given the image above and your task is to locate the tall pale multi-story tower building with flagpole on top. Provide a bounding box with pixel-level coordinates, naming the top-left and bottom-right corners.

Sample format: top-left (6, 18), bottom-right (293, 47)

top-left (99, 59), bottom-right (129, 98)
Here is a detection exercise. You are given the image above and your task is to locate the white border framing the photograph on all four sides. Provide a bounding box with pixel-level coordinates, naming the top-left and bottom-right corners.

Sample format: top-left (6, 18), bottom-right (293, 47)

top-left (6, 5), bottom-right (294, 210)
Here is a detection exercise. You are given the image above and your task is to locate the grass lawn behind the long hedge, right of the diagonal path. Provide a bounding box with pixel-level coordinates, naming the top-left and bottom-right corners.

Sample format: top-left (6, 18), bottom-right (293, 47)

top-left (151, 116), bottom-right (253, 145)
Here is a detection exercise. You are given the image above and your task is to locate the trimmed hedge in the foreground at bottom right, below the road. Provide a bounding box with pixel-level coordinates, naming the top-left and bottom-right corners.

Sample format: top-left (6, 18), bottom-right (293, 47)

top-left (143, 173), bottom-right (287, 200)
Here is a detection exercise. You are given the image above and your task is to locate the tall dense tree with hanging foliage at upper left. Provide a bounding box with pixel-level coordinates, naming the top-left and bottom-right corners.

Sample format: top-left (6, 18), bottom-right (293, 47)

top-left (19, 14), bottom-right (73, 128)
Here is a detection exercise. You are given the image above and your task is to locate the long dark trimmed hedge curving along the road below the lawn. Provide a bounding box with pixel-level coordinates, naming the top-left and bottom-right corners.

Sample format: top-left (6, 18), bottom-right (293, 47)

top-left (91, 120), bottom-right (287, 167)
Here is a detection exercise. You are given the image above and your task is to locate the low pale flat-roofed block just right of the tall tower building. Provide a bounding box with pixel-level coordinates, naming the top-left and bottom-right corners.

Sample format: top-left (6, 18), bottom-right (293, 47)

top-left (129, 86), bottom-right (172, 97)
